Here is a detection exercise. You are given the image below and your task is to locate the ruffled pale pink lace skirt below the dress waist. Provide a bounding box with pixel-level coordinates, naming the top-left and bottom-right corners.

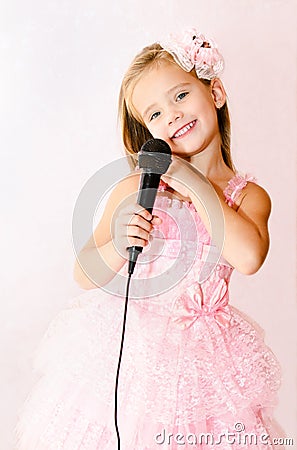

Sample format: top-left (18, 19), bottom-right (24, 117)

top-left (16, 289), bottom-right (282, 450)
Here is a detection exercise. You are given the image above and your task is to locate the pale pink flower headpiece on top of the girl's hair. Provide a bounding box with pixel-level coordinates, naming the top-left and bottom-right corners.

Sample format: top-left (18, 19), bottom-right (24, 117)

top-left (159, 28), bottom-right (224, 80)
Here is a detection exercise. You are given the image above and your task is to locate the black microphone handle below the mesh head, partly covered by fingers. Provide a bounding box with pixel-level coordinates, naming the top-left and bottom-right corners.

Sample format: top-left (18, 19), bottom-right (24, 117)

top-left (127, 172), bottom-right (161, 275)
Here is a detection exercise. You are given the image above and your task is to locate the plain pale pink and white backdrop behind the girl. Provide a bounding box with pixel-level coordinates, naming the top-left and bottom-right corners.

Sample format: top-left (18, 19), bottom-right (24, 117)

top-left (0, 0), bottom-right (297, 450)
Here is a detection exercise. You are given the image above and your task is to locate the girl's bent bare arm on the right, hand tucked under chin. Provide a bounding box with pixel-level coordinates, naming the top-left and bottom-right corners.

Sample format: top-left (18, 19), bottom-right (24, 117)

top-left (165, 161), bottom-right (271, 274)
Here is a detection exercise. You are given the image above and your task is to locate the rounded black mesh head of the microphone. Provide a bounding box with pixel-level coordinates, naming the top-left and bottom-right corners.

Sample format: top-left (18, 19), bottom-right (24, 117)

top-left (138, 139), bottom-right (171, 175)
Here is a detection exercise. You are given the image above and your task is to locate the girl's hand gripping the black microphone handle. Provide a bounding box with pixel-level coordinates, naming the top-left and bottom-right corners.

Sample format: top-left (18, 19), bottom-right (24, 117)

top-left (112, 195), bottom-right (162, 259)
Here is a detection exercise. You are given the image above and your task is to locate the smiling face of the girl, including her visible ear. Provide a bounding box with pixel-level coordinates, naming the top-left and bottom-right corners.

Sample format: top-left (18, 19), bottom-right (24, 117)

top-left (132, 61), bottom-right (226, 158)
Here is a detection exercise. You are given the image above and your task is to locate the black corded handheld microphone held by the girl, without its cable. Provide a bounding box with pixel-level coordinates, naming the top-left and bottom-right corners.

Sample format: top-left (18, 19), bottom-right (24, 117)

top-left (127, 139), bottom-right (171, 275)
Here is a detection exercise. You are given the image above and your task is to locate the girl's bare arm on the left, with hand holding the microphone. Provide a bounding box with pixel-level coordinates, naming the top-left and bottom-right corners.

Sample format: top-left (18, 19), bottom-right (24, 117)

top-left (73, 173), bottom-right (160, 289)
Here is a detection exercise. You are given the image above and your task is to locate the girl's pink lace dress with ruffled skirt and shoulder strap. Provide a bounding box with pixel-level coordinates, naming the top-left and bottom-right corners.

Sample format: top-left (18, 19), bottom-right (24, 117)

top-left (16, 174), bottom-right (282, 450)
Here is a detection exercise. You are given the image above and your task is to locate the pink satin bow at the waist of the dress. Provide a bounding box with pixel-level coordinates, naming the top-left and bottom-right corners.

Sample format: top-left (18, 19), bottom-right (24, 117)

top-left (172, 279), bottom-right (231, 329)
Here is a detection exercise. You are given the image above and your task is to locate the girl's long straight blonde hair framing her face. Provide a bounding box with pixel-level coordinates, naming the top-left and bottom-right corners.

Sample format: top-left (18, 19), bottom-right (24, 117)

top-left (119, 44), bottom-right (234, 171)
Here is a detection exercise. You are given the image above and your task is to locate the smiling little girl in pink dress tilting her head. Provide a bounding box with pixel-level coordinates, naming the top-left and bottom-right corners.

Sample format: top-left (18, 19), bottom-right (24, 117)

top-left (16, 30), bottom-right (281, 450)
